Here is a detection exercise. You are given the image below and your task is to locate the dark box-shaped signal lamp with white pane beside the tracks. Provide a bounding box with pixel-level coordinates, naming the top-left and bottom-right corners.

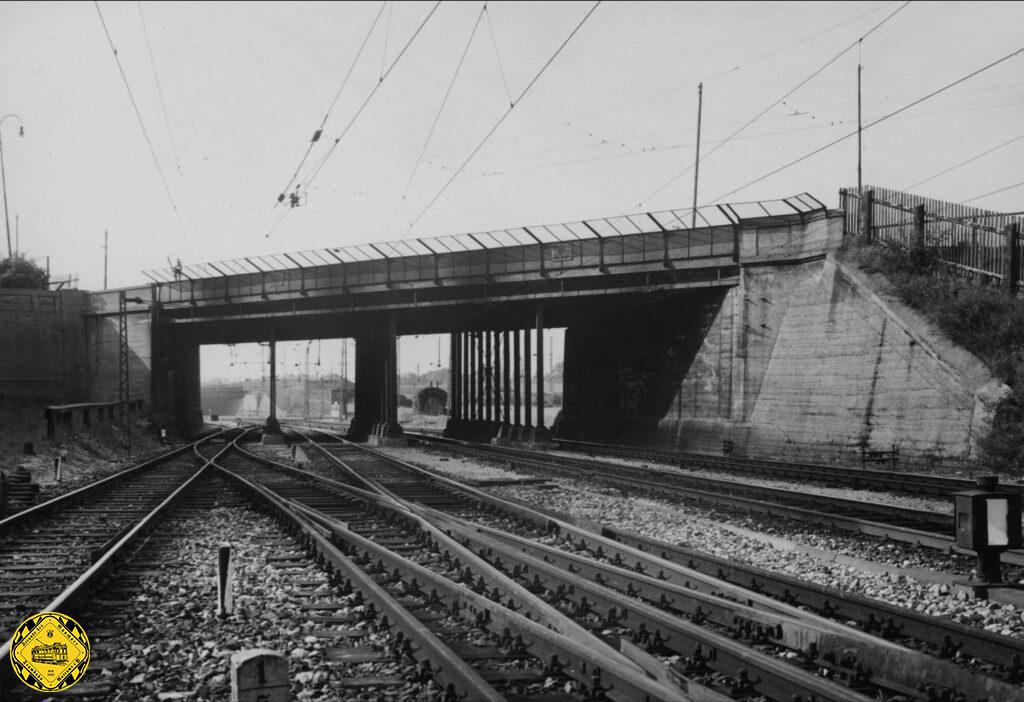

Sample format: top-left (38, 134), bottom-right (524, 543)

top-left (953, 479), bottom-right (1022, 551)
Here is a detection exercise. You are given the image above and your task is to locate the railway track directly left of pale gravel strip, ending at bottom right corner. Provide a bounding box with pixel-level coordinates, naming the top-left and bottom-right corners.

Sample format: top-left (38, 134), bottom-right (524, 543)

top-left (280, 425), bottom-right (1022, 699)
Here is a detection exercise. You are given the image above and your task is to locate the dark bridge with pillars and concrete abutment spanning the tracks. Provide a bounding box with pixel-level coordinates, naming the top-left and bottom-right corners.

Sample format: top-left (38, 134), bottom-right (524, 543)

top-left (77, 193), bottom-right (999, 459)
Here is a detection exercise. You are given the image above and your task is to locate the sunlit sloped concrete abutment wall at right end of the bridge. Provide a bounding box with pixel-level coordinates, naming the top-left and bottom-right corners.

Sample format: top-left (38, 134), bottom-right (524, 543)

top-left (659, 255), bottom-right (1008, 466)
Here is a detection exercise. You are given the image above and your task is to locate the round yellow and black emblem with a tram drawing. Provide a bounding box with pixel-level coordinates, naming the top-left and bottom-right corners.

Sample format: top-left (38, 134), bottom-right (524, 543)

top-left (10, 612), bottom-right (92, 692)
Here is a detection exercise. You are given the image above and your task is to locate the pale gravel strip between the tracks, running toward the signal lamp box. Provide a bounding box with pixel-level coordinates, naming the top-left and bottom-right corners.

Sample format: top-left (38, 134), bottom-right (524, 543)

top-left (374, 448), bottom-right (1024, 638)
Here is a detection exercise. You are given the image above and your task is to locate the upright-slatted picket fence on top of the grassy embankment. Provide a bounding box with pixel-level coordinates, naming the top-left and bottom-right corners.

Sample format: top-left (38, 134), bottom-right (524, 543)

top-left (839, 186), bottom-right (1024, 294)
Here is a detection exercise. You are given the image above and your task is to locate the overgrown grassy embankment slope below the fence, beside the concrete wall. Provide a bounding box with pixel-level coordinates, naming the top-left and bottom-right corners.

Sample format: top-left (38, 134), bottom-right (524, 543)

top-left (843, 244), bottom-right (1024, 476)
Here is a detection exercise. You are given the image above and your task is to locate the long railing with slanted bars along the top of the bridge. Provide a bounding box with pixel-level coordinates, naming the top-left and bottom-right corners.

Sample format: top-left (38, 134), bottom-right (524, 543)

top-left (144, 193), bottom-right (824, 302)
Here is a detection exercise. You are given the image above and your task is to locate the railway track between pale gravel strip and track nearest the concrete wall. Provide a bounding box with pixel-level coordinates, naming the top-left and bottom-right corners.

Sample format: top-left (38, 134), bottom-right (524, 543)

top-left (407, 433), bottom-right (1024, 565)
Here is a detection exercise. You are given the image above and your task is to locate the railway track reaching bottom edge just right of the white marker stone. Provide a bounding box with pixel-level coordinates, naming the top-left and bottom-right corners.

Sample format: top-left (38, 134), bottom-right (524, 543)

top-left (207, 440), bottom-right (679, 701)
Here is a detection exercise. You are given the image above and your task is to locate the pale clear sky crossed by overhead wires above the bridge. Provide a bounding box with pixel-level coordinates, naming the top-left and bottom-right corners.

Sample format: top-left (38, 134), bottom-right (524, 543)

top-left (0, 1), bottom-right (1024, 378)
